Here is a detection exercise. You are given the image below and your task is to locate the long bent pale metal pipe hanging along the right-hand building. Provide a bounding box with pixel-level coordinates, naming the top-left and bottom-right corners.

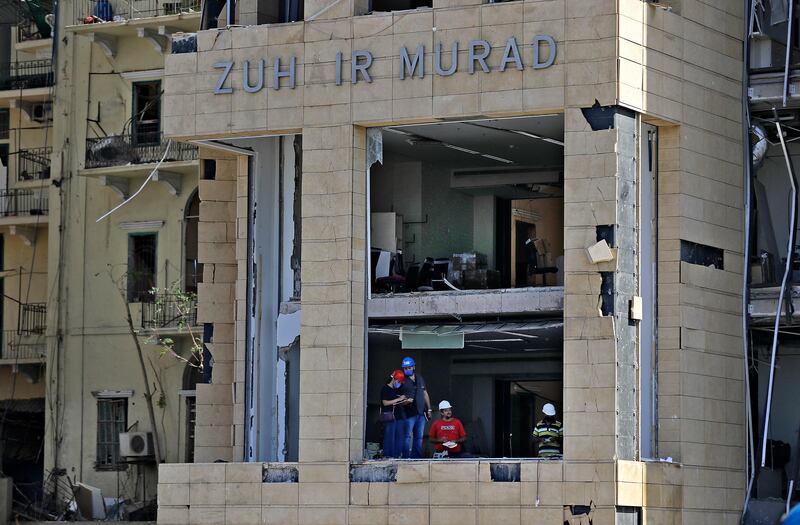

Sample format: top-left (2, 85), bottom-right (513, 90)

top-left (761, 119), bottom-right (797, 468)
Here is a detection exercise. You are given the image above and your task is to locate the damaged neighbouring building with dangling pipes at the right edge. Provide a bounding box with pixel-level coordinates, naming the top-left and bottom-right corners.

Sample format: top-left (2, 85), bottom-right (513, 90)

top-left (742, 0), bottom-right (800, 523)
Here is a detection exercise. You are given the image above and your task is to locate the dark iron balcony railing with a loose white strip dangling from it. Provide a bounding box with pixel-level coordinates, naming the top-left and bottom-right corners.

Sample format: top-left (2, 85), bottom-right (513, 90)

top-left (86, 133), bottom-right (197, 168)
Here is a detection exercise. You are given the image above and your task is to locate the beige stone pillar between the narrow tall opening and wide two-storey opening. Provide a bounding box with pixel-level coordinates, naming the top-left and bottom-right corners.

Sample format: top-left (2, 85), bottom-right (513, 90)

top-left (299, 125), bottom-right (364, 462)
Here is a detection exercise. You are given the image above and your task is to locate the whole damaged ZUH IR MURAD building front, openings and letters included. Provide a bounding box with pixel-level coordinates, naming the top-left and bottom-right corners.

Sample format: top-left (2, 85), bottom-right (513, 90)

top-left (145, 0), bottom-right (746, 524)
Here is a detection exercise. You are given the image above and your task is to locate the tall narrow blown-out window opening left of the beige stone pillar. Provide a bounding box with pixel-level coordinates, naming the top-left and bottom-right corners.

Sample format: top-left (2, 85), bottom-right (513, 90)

top-left (204, 135), bottom-right (303, 461)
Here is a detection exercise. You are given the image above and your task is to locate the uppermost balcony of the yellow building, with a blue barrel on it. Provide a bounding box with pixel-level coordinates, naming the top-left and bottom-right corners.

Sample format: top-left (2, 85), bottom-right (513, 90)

top-left (68, 0), bottom-right (201, 47)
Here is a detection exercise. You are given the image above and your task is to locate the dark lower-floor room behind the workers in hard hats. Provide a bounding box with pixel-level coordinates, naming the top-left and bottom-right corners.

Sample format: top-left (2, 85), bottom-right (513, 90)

top-left (366, 318), bottom-right (563, 458)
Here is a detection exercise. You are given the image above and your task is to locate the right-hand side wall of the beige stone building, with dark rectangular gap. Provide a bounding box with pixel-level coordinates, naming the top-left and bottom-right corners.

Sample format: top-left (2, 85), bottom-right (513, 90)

top-left (619, 0), bottom-right (745, 521)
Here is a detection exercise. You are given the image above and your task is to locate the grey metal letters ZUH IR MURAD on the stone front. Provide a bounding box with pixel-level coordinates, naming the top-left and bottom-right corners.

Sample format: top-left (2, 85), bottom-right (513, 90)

top-left (214, 35), bottom-right (556, 95)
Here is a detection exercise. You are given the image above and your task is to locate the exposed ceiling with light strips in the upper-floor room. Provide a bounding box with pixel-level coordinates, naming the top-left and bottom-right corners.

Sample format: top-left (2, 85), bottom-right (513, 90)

top-left (383, 114), bottom-right (564, 169)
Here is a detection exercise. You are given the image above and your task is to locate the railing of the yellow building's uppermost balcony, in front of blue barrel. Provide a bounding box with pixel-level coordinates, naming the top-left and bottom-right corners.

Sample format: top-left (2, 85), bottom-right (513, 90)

top-left (75, 0), bottom-right (200, 22)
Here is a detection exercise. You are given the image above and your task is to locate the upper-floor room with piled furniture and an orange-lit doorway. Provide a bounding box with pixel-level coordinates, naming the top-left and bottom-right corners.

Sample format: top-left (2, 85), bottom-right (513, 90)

top-left (369, 114), bottom-right (564, 295)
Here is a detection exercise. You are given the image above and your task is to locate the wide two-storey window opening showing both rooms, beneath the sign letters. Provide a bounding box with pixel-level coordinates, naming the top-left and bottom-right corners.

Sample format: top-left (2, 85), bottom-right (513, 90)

top-left (365, 114), bottom-right (564, 458)
